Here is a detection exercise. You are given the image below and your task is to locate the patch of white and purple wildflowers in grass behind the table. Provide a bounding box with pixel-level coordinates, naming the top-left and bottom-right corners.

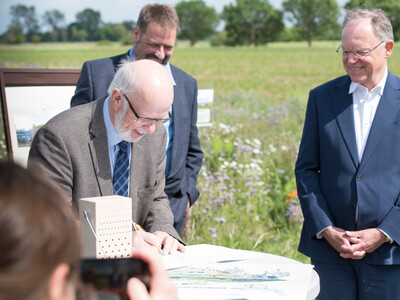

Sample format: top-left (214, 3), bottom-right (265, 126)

top-left (186, 92), bottom-right (303, 259)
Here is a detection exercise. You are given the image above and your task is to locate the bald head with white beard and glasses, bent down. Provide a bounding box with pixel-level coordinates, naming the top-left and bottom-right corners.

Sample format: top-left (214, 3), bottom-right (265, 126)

top-left (108, 59), bottom-right (174, 142)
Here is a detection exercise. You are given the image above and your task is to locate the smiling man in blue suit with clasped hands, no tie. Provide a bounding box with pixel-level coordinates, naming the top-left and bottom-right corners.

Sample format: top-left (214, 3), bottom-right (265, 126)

top-left (295, 8), bottom-right (400, 300)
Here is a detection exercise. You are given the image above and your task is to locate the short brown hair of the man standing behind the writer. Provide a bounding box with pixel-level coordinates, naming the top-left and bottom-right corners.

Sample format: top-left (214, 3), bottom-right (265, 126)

top-left (137, 4), bottom-right (179, 34)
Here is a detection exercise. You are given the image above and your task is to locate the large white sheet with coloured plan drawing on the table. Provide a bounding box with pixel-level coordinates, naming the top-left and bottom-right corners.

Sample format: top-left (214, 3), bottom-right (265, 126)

top-left (163, 245), bottom-right (312, 300)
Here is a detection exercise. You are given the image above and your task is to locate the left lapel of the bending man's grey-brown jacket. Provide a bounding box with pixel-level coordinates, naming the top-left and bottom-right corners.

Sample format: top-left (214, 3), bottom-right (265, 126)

top-left (89, 98), bottom-right (113, 196)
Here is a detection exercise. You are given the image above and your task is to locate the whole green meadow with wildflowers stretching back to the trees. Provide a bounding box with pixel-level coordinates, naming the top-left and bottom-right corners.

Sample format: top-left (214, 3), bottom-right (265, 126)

top-left (0, 41), bottom-right (400, 263)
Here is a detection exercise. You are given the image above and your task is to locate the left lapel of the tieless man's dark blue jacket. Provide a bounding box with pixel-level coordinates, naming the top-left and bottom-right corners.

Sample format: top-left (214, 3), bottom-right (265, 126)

top-left (331, 76), bottom-right (358, 167)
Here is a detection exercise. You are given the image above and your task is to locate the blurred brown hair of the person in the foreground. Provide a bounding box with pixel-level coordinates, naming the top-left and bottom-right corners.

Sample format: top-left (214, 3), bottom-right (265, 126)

top-left (0, 162), bottom-right (80, 300)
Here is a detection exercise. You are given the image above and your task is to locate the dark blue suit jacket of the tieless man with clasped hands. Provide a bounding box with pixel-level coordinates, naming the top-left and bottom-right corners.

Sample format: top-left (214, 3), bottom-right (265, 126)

top-left (295, 73), bottom-right (400, 264)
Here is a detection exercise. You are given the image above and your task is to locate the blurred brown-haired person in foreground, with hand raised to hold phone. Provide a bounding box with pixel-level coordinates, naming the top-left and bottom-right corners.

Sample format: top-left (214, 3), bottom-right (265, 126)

top-left (0, 162), bottom-right (177, 300)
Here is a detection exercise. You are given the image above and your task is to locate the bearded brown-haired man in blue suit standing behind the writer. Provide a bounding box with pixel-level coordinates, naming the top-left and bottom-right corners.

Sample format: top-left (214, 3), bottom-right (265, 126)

top-left (71, 4), bottom-right (203, 232)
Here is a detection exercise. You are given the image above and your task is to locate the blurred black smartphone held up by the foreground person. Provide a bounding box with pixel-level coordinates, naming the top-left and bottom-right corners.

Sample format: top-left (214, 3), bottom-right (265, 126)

top-left (77, 258), bottom-right (150, 300)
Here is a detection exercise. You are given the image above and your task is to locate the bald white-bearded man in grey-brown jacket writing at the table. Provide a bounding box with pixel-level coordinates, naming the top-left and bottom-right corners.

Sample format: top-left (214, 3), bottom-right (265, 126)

top-left (28, 60), bottom-right (184, 253)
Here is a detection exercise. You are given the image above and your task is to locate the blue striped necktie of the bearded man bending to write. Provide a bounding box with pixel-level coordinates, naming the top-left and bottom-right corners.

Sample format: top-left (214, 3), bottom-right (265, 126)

top-left (113, 141), bottom-right (129, 197)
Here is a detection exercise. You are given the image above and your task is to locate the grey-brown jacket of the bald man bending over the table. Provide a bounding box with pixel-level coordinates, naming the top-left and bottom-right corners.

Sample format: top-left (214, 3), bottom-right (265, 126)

top-left (28, 98), bottom-right (181, 241)
